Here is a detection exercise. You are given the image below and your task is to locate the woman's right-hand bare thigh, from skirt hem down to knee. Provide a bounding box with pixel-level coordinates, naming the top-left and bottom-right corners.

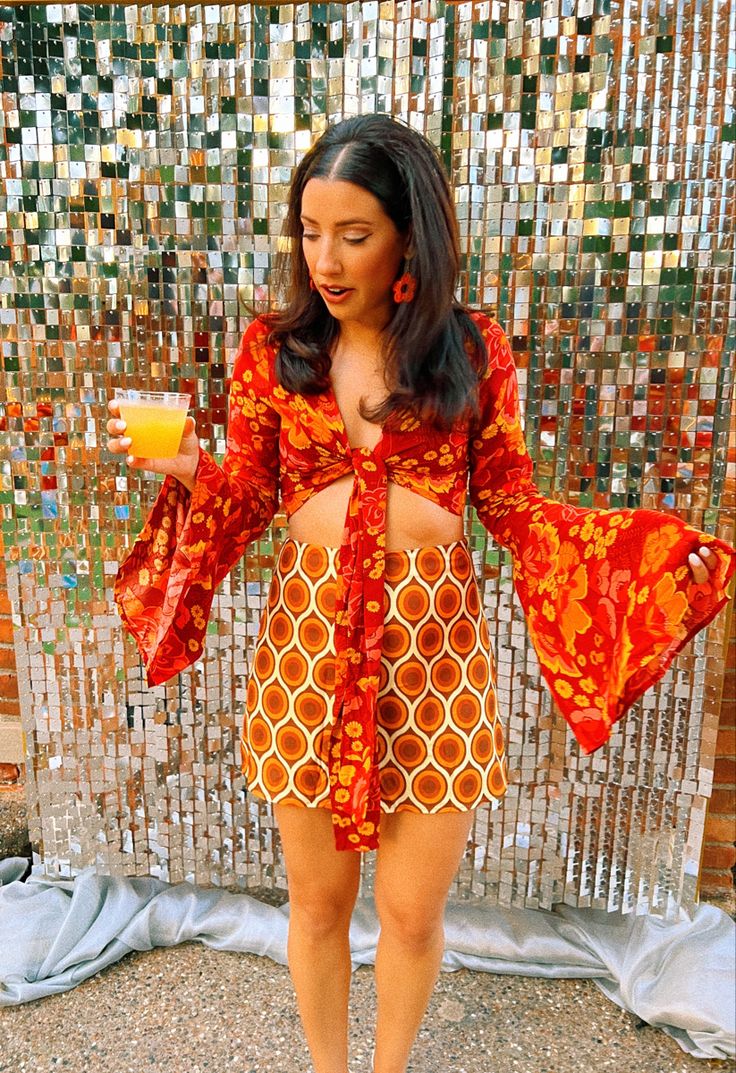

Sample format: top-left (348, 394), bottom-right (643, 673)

top-left (374, 809), bottom-right (474, 930)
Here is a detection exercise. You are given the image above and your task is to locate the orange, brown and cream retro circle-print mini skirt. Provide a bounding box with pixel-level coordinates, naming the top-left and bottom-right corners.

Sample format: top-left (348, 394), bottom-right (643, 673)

top-left (240, 539), bottom-right (507, 812)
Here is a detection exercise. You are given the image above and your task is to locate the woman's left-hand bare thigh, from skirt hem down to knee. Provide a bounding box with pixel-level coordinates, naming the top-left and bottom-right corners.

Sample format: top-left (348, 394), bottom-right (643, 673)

top-left (274, 805), bottom-right (360, 917)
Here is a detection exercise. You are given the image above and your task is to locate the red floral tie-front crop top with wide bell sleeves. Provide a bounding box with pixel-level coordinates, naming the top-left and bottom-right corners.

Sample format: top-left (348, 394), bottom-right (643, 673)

top-left (115, 313), bottom-right (736, 850)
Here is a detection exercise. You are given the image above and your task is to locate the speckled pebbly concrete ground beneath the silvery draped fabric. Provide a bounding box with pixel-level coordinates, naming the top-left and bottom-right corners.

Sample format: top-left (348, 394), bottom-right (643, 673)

top-left (0, 790), bottom-right (736, 1073)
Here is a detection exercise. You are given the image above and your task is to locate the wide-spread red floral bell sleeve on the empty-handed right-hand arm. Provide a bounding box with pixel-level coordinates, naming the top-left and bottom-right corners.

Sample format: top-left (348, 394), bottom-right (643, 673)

top-left (470, 321), bottom-right (736, 752)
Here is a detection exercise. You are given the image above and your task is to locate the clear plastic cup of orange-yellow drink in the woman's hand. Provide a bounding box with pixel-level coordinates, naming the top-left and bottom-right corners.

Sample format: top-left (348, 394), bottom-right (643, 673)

top-left (115, 387), bottom-right (192, 458)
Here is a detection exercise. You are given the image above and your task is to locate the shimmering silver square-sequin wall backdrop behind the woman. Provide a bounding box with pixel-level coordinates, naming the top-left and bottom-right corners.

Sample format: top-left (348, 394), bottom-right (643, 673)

top-left (0, 0), bottom-right (736, 914)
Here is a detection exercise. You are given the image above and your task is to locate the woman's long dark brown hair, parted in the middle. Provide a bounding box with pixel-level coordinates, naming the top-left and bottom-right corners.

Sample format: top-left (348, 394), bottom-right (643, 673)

top-left (265, 115), bottom-right (487, 428)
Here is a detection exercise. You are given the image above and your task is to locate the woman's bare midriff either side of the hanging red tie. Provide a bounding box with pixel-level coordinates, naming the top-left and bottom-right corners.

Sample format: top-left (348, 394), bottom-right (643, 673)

top-left (289, 476), bottom-right (465, 552)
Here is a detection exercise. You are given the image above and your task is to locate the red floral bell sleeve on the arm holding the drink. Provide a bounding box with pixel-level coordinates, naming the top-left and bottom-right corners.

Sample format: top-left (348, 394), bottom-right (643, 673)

top-left (115, 321), bottom-right (279, 686)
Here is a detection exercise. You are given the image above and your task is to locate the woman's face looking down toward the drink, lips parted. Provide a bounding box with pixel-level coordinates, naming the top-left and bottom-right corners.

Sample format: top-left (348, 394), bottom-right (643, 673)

top-left (301, 179), bottom-right (409, 330)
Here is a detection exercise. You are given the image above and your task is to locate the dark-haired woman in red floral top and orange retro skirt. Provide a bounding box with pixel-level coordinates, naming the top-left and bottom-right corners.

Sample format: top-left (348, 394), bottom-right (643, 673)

top-left (107, 116), bottom-right (734, 1073)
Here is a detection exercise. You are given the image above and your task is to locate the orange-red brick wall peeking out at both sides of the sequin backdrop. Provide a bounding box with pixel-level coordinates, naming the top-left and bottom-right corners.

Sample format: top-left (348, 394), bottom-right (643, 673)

top-left (0, 558), bottom-right (736, 894)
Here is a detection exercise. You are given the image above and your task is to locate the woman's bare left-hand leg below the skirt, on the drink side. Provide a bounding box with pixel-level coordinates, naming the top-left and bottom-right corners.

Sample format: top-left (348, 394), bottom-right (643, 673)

top-left (274, 805), bottom-right (360, 1073)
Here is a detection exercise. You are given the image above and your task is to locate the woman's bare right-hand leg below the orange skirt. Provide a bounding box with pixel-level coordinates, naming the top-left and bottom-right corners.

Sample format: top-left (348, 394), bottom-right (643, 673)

top-left (373, 811), bottom-right (473, 1073)
